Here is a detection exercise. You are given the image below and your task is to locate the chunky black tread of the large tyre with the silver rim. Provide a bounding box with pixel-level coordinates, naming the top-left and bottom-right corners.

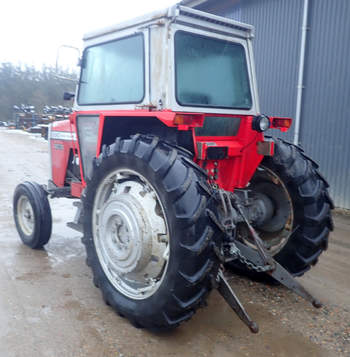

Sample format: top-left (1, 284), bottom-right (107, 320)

top-left (82, 135), bottom-right (219, 330)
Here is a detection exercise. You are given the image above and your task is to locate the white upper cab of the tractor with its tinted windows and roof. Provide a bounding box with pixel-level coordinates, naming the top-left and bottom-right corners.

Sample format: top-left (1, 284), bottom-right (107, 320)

top-left (74, 6), bottom-right (259, 115)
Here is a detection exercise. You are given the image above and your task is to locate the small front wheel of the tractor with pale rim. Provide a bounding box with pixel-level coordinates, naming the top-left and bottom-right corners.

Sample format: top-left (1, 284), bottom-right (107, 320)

top-left (13, 181), bottom-right (52, 249)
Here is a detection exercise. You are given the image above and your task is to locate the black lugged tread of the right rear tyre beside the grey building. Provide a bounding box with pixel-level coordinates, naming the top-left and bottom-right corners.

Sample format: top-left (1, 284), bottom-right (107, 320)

top-left (270, 139), bottom-right (334, 276)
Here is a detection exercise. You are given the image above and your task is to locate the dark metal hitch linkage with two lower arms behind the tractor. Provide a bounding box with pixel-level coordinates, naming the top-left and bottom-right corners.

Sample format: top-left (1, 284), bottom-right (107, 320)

top-left (211, 190), bottom-right (322, 333)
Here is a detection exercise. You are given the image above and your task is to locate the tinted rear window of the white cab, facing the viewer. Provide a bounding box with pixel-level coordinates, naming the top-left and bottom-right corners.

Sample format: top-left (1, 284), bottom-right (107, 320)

top-left (175, 31), bottom-right (252, 109)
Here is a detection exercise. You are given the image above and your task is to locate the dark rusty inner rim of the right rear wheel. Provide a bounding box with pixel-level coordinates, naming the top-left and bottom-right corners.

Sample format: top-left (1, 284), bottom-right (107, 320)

top-left (239, 166), bottom-right (294, 256)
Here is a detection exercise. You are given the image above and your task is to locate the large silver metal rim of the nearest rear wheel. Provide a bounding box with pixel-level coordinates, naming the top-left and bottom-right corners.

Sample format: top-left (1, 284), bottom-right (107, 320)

top-left (93, 169), bottom-right (170, 300)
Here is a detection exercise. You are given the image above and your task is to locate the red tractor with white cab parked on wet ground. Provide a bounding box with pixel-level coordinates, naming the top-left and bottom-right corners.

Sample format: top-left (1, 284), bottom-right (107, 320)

top-left (13, 6), bottom-right (333, 332)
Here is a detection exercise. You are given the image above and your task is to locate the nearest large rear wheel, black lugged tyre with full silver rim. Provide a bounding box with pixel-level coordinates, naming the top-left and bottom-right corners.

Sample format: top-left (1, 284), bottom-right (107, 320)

top-left (82, 135), bottom-right (218, 330)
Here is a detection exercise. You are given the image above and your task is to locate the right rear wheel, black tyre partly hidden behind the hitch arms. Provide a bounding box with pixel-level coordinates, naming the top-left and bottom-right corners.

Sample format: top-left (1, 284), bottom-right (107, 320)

top-left (232, 139), bottom-right (334, 276)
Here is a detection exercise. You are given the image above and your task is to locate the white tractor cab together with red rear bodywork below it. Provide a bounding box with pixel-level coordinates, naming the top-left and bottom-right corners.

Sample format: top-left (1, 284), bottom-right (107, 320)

top-left (63, 6), bottom-right (291, 190)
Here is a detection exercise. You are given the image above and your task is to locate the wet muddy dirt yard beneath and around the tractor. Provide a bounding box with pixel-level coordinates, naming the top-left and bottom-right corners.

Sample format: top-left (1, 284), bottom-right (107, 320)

top-left (0, 129), bottom-right (350, 357)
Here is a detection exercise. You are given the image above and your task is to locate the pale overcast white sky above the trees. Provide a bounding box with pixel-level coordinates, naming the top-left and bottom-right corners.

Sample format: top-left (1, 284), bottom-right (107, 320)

top-left (0, 0), bottom-right (178, 68)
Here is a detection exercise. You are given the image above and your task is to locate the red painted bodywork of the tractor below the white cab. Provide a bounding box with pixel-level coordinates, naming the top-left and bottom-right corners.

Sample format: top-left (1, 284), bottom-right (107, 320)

top-left (51, 110), bottom-right (288, 197)
